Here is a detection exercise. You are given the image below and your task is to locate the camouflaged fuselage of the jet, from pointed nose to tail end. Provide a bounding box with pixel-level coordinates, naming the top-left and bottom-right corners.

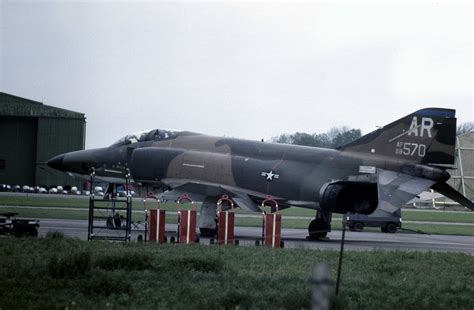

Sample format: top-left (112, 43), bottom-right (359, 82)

top-left (50, 133), bottom-right (449, 212)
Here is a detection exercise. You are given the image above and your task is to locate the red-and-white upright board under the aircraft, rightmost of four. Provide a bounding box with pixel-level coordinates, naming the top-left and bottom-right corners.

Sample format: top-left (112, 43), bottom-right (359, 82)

top-left (260, 196), bottom-right (283, 248)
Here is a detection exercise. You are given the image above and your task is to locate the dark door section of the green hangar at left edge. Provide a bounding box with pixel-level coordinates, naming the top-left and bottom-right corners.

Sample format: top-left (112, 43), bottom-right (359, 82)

top-left (0, 117), bottom-right (37, 186)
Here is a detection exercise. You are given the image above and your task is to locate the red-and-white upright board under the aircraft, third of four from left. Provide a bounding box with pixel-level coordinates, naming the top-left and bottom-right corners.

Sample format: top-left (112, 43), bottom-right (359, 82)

top-left (217, 195), bottom-right (238, 244)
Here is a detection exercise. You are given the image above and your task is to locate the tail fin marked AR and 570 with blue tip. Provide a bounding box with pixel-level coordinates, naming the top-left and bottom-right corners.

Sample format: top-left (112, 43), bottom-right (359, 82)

top-left (341, 108), bottom-right (456, 166)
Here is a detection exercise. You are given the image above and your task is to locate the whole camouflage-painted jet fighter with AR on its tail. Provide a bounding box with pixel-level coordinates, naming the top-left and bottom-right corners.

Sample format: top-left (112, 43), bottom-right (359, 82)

top-left (48, 108), bottom-right (474, 238)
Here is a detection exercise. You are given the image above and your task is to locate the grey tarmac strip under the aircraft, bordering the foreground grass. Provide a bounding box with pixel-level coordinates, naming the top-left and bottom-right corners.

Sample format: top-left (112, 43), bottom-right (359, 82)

top-left (39, 219), bottom-right (474, 255)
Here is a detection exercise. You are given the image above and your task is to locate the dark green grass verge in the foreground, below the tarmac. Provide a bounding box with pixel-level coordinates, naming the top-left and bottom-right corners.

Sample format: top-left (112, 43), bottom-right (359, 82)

top-left (0, 234), bottom-right (474, 309)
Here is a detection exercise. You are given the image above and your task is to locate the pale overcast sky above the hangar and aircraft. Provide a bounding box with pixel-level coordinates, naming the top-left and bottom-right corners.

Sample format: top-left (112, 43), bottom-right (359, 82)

top-left (0, 0), bottom-right (474, 148)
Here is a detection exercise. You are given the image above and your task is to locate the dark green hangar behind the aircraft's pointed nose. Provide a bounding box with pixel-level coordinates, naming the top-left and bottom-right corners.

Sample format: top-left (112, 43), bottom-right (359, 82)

top-left (0, 92), bottom-right (86, 186)
